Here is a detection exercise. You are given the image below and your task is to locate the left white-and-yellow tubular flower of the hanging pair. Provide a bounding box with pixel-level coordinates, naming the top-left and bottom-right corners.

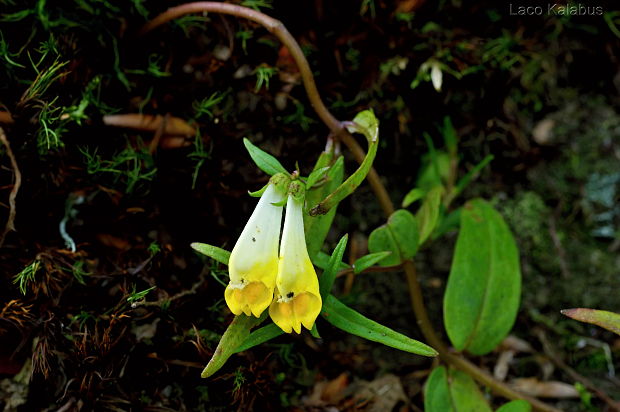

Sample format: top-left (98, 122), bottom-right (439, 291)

top-left (224, 183), bottom-right (284, 317)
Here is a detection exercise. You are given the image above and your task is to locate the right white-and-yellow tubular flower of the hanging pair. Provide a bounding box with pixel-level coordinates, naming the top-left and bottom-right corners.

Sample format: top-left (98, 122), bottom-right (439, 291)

top-left (269, 194), bottom-right (322, 333)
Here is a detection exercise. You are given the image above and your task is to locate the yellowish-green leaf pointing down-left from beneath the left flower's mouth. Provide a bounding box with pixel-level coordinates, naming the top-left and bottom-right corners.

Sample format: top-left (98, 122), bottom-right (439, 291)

top-left (200, 311), bottom-right (266, 378)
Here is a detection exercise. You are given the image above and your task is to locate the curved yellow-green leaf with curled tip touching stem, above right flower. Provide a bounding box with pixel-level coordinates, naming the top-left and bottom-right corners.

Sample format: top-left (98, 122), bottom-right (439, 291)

top-left (310, 110), bottom-right (379, 216)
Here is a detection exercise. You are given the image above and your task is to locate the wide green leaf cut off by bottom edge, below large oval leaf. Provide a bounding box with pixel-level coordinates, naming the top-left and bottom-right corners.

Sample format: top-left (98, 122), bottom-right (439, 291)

top-left (424, 366), bottom-right (491, 412)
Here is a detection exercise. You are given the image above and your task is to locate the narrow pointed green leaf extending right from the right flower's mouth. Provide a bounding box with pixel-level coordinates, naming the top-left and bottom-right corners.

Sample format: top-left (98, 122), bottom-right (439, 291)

top-left (321, 295), bottom-right (437, 356)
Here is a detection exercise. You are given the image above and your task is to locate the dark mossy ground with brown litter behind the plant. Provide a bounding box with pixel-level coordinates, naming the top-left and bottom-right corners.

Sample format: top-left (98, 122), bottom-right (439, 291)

top-left (0, 0), bottom-right (620, 411)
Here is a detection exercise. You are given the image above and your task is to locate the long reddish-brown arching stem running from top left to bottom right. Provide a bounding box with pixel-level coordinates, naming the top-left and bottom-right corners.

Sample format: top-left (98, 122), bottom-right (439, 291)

top-left (145, 1), bottom-right (559, 412)
